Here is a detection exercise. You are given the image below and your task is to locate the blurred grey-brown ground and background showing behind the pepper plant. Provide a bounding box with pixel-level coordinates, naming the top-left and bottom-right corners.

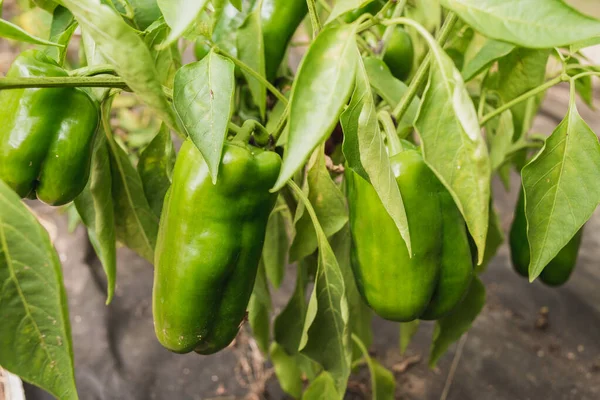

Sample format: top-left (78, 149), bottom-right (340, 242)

top-left (0, 0), bottom-right (600, 400)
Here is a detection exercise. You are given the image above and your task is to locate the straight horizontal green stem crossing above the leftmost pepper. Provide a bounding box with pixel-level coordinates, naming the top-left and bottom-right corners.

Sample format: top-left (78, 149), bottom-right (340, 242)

top-left (0, 77), bottom-right (129, 90)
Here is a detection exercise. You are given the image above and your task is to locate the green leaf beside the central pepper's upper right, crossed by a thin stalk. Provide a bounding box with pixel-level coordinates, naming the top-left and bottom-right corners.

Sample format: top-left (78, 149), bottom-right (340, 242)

top-left (290, 148), bottom-right (348, 261)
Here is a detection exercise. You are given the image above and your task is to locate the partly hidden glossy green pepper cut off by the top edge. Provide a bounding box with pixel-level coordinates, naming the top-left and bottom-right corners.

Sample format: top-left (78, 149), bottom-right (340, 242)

top-left (260, 0), bottom-right (308, 81)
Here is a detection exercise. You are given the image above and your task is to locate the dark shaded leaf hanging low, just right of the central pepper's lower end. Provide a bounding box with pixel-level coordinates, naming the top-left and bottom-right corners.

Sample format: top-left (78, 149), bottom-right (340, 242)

top-left (273, 260), bottom-right (308, 355)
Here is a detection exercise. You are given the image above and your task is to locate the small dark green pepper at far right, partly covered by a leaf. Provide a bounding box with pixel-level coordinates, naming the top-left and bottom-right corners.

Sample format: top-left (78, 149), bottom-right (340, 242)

top-left (510, 190), bottom-right (583, 286)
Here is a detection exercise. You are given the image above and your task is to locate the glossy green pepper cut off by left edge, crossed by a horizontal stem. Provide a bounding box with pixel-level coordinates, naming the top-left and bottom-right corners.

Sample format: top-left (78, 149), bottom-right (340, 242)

top-left (0, 50), bottom-right (99, 206)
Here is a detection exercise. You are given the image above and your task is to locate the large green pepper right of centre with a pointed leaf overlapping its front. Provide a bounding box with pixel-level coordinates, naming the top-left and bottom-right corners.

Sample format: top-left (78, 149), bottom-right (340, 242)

top-left (346, 150), bottom-right (473, 322)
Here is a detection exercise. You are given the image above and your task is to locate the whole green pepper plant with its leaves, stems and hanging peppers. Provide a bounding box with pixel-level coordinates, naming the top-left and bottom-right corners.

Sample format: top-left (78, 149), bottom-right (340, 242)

top-left (0, 0), bottom-right (600, 399)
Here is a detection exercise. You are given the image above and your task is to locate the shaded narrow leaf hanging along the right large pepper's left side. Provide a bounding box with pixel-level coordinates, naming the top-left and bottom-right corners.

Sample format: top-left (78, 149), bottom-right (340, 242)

top-left (331, 224), bottom-right (373, 360)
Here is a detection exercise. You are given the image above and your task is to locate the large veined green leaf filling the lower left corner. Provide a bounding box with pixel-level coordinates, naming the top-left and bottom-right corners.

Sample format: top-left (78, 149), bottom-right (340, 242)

top-left (0, 181), bottom-right (78, 400)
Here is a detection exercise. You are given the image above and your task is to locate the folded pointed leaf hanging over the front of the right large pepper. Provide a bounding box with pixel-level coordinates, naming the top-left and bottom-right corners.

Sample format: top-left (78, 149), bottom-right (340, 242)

top-left (341, 55), bottom-right (414, 251)
